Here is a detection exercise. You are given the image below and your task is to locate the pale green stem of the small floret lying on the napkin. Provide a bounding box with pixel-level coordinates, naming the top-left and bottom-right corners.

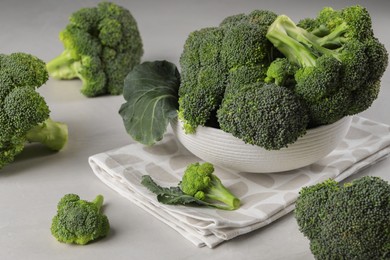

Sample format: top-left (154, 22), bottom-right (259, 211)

top-left (205, 175), bottom-right (240, 210)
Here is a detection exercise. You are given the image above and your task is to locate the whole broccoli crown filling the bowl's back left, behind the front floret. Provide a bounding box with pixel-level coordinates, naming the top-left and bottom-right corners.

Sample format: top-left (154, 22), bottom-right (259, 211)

top-left (179, 10), bottom-right (278, 133)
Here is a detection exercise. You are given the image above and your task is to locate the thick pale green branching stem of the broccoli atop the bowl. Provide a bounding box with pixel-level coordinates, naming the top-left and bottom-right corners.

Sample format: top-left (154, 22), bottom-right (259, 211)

top-left (266, 15), bottom-right (346, 67)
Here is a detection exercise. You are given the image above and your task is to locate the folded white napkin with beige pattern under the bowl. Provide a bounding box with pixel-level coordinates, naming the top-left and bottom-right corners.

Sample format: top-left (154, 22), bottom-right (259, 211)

top-left (89, 116), bottom-right (390, 248)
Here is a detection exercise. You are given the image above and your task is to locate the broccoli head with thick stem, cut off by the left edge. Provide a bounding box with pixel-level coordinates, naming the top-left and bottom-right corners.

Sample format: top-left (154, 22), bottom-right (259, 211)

top-left (0, 53), bottom-right (68, 169)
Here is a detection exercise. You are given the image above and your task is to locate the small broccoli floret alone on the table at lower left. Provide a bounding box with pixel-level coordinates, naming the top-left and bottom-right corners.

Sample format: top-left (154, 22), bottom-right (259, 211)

top-left (51, 194), bottom-right (110, 245)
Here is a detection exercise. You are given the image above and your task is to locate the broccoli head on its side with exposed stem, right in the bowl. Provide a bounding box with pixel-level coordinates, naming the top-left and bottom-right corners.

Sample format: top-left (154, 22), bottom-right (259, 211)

top-left (266, 5), bottom-right (388, 127)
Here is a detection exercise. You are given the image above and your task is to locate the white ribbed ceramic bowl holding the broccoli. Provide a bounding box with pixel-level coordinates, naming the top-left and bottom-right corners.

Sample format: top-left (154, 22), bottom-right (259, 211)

top-left (171, 117), bottom-right (352, 173)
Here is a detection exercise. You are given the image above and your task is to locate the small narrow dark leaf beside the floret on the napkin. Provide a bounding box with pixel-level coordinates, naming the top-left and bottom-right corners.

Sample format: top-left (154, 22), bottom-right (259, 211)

top-left (141, 175), bottom-right (209, 206)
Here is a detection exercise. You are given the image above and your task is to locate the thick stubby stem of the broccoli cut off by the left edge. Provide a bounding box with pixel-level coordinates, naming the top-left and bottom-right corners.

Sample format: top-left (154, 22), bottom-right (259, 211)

top-left (26, 118), bottom-right (68, 151)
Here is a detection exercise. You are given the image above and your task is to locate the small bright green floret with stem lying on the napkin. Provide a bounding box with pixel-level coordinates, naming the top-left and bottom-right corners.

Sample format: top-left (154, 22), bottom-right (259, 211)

top-left (180, 162), bottom-right (240, 210)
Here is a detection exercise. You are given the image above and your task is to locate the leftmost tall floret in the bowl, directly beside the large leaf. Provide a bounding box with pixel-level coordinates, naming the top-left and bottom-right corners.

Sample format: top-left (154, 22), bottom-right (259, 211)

top-left (179, 28), bottom-right (226, 133)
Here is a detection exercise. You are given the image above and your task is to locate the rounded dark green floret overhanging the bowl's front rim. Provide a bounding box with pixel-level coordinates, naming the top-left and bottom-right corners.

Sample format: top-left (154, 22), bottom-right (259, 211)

top-left (217, 82), bottom-right (308, 150)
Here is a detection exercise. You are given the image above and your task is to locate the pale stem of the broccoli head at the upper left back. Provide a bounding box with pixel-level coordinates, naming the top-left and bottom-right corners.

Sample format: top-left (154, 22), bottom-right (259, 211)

top-left (46, 50), bottom-right (81, 79)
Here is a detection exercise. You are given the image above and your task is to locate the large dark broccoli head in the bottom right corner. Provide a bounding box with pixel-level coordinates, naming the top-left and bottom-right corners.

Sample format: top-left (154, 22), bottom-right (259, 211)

top-left (294, 176), bottom-right (390, 259)
